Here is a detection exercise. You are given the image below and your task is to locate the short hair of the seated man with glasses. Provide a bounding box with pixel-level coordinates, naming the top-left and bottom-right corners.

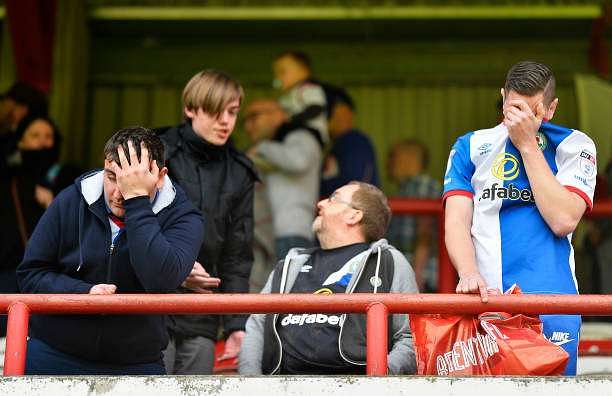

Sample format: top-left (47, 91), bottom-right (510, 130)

top-left (349, 181), bottom-right (391, 242)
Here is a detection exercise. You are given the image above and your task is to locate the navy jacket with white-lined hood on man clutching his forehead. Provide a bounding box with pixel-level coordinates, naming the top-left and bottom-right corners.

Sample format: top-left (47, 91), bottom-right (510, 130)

top-left (17, 171), bottom-right (204, 364)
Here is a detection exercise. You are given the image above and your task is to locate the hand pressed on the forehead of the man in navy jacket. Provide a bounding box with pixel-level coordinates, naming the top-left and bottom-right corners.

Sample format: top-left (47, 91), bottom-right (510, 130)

top-left (111, 140), bottom-right (159, 199)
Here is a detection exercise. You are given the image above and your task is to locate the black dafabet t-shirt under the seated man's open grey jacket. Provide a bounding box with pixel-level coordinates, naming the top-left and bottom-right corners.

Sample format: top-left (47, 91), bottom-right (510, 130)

top-left (277, 243), bottom-right (368, 374)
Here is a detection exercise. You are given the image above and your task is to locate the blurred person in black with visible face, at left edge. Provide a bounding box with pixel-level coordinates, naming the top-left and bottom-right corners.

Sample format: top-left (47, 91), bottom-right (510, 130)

top-left (0, 115), bottom-right (82, 372)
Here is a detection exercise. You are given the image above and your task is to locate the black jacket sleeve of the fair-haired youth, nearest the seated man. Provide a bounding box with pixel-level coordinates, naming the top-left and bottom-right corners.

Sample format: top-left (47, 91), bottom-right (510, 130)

top-left (218, 175), bottom-right (254, 335)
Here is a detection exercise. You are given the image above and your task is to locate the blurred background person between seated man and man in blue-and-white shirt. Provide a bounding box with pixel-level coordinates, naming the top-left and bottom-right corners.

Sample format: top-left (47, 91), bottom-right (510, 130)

top-left (387, 139), bottom-right (441, 292)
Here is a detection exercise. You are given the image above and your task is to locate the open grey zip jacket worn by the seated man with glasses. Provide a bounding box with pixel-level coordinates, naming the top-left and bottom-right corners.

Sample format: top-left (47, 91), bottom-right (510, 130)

top-left (238, 239), bottom-right (418, 375)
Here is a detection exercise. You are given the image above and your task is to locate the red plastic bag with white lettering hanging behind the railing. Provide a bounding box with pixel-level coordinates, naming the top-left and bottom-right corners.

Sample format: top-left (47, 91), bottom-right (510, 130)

top-left (410, 292), bottom-right (569, 376)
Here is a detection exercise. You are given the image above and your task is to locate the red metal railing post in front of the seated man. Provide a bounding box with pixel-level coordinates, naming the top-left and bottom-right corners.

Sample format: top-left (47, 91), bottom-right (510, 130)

top-left (366, 303), bottom-right (389, 376)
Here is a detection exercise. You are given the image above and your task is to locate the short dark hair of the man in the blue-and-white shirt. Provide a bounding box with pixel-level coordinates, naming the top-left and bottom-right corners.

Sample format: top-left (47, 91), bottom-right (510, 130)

top-left (504, 61), bottom-right (556, 104)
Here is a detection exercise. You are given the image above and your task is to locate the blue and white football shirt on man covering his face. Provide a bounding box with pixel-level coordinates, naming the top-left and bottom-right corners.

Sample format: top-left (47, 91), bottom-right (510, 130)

top-left (444, 122), bottom-right (597, 294)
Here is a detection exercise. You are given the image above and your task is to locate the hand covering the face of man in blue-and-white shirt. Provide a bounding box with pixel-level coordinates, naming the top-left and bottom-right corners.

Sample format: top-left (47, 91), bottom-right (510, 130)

top-left (503, 99), bottom-right (545, 152)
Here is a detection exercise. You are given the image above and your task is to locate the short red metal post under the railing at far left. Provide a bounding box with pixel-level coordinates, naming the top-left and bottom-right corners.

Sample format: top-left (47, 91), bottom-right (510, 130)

top-left (4, 302), bottom-right (30, 375)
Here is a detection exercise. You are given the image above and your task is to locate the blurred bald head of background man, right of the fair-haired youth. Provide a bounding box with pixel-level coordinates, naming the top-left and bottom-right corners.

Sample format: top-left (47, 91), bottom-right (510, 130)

top-left (244, 99), bottom-right (288, 143)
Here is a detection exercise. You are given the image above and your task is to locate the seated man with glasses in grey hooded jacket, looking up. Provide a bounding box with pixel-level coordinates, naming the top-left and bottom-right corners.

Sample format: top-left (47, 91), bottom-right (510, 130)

top-left (239, 182), bottom-right (418, 375)
